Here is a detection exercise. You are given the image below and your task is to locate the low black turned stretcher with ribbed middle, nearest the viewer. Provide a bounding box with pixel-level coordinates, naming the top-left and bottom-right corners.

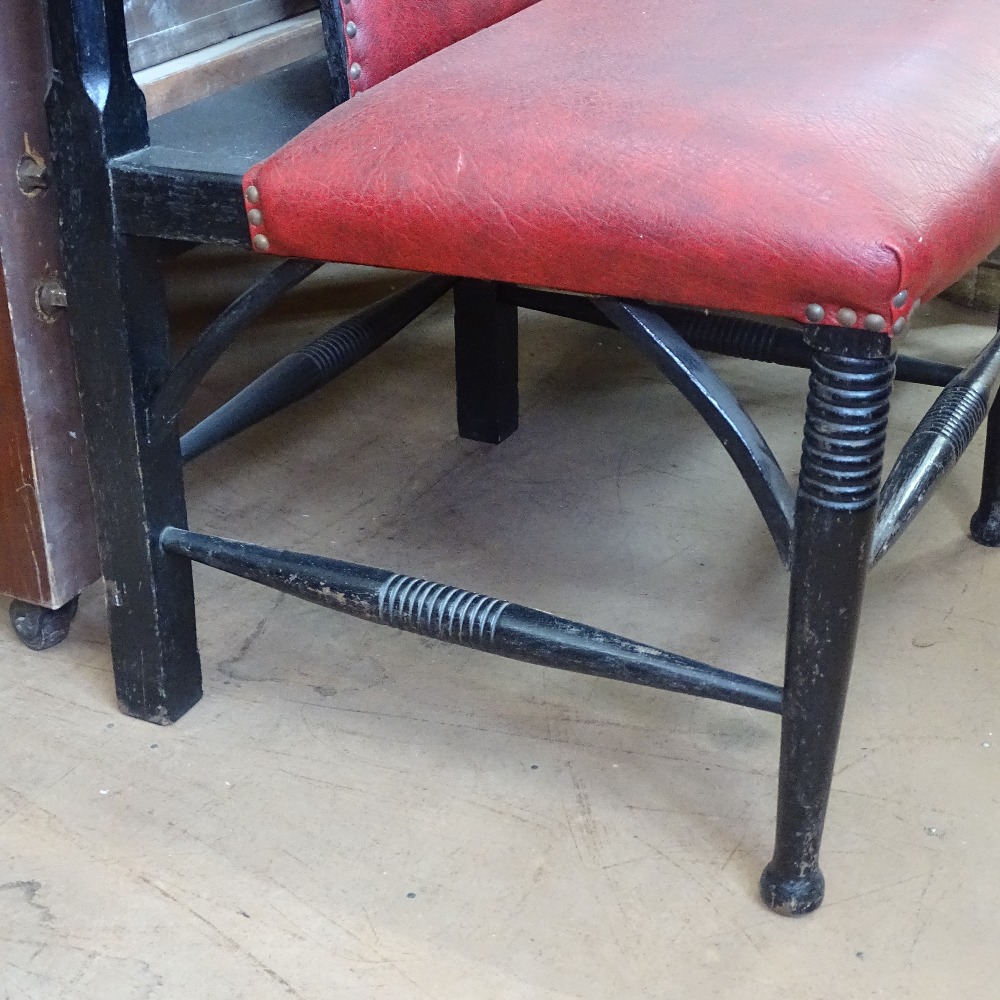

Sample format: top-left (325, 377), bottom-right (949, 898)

top-left (160, 528), bottom-right (782, 714)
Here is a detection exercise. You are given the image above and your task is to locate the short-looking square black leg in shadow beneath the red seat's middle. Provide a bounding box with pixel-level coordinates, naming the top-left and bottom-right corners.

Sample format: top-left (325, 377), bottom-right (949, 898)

top-left (455, 280), bottom-right (517, 444)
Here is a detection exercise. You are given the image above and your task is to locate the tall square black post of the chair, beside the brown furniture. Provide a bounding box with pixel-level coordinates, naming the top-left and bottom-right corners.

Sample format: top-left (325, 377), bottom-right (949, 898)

top-left (48, 0), bottom-right (201, 724)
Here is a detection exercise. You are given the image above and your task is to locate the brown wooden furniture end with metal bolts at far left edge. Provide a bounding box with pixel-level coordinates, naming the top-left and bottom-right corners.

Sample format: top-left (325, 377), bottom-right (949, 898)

top-left (0, 0), bottom-right (99, 608)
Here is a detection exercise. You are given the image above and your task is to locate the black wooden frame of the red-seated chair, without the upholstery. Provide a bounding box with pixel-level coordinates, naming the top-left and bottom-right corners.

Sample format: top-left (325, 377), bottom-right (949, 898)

top-left (48, 0), bottom-right (1000, 914)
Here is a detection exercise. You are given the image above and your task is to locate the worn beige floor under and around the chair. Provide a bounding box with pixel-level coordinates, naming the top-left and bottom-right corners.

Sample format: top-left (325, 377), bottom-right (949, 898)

top-left (0, 248), bottom-right (1000, 1000)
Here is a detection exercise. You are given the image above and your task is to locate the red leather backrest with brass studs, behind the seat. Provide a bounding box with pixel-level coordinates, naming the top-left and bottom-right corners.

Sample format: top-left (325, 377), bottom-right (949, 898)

top-left (336, 0), bottom-right (537, 95)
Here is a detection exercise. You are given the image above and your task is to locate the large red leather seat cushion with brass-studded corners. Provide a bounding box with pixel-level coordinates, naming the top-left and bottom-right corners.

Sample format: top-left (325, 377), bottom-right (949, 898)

top-left (246, 0), bottom-right (1000, 336)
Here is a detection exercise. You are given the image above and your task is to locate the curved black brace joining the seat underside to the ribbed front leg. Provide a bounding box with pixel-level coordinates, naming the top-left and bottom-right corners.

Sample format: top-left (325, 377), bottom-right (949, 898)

top-left (596, 299), bottom-right (795, 567)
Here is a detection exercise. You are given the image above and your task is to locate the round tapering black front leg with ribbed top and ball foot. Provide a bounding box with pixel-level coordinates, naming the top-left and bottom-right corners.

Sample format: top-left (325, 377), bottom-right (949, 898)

top-left (760, 328), bottom-right (893, 916)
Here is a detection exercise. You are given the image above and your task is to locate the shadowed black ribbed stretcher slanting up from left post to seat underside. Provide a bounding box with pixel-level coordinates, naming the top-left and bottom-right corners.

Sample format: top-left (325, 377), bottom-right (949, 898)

top-left (181, 276), bottom-right (454, 460)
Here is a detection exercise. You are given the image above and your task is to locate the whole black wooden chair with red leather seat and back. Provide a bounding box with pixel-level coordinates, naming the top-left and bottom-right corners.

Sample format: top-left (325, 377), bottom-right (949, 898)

top-left (49, 0), bottom-right (1000, 915)
